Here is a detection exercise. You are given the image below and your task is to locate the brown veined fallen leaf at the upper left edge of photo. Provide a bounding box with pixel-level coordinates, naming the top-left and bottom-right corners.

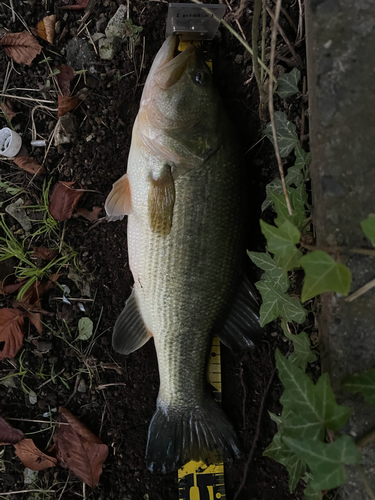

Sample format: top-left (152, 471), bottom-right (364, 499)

top-left (0, 31), bottom-right (42, 66)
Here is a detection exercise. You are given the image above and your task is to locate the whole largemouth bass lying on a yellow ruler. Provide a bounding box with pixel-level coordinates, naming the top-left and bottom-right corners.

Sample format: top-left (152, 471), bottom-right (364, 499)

top-left (105, 35), bottom-right (261, 473)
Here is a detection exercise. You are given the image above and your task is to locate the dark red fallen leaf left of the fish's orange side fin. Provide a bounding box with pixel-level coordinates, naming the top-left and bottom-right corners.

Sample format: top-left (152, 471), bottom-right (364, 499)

top-left (48, 181), bottom-right (84, 221)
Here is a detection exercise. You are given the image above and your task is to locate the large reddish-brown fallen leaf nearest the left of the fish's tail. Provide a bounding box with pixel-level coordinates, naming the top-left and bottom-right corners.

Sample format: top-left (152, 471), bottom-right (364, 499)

top-left (53, 407), bottom-right (108, 488)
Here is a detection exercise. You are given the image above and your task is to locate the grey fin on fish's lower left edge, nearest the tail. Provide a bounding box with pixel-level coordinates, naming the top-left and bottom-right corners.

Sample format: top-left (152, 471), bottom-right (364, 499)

top-left (112, 290), bottom-right (152, 354)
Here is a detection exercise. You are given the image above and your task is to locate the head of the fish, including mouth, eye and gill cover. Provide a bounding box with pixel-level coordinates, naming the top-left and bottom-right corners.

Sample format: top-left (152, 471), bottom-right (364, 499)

top-left (139, 35), bottom-right (220, 170)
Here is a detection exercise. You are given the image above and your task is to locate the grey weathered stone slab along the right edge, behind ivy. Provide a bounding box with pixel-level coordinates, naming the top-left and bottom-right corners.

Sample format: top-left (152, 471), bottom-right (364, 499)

top-left (306, 0), bottom-right (375, 500)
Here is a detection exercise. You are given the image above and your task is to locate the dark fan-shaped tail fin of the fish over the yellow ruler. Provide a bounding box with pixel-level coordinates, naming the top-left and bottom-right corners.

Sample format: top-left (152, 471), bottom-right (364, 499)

top-left (146, 395), bottom-right (241, 473)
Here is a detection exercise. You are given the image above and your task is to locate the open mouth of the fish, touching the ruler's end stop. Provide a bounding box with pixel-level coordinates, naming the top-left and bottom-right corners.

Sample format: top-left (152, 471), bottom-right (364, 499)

top-left (154, 35), bottom-right (196, 89)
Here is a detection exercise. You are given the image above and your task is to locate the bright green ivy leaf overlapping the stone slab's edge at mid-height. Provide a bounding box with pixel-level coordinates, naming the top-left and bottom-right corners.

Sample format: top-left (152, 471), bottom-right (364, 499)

top-left (300, 249), bottom-right (351, 302)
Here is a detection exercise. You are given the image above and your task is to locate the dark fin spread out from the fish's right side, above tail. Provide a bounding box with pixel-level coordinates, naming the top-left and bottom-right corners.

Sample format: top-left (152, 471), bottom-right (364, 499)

top-left (219, 276), bottom-right (262, 351)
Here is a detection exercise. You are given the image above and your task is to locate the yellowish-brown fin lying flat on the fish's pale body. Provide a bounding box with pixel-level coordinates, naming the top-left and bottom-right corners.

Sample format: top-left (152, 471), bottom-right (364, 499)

top-left (148, 165), bottom-right (176, 236)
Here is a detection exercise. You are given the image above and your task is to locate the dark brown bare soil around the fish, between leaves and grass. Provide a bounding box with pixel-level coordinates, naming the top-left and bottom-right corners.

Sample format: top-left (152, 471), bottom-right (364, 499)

top-left (0, 0), bottom-right (312, 500)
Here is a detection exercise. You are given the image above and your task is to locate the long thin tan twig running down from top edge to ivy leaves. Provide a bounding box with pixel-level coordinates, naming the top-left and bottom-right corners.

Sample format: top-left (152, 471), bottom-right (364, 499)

top-left (267, 0), bottom-right (293, 215)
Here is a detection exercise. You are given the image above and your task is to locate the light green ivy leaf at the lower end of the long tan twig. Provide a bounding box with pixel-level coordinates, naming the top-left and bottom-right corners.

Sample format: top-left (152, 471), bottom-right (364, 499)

top-left (260, 220), bottom-right (302, 272)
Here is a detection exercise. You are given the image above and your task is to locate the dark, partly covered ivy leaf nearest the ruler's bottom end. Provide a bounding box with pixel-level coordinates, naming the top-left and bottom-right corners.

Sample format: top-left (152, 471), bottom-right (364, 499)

top-left (263, 432), bottom-right (306, 493)
